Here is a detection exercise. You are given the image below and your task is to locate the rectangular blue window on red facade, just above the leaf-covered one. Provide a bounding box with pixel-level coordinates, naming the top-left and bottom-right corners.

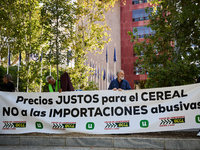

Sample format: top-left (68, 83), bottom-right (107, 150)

top-left (132, 9), bottom-right (152, 22)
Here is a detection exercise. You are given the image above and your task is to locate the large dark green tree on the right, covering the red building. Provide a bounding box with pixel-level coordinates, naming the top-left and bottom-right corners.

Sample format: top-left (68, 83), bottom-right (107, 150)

top-left (129, 0), bottom-right (200, 88)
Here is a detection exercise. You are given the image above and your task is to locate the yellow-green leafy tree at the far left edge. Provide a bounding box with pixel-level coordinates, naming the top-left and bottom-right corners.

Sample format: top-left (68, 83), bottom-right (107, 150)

top-left (0, 0), bottom-right (43, 91)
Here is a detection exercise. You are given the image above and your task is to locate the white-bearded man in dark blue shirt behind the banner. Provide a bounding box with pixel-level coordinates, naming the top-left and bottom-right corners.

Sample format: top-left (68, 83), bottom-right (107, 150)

top-left (108, 70), bottom-right (131, 91)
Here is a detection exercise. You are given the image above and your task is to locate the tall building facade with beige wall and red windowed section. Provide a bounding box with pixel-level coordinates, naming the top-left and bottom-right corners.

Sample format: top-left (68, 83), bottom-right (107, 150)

top-left (88, 0), bottom-right (152, 90)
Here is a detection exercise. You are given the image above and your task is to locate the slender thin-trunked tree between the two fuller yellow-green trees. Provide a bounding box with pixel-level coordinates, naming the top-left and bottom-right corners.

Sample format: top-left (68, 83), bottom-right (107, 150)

top-left (41, 0), bottom-right (75, 91)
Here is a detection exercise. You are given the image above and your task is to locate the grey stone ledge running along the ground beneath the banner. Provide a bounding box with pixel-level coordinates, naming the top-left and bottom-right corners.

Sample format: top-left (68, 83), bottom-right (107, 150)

top-left (0, 131), bottom-right (200, 150)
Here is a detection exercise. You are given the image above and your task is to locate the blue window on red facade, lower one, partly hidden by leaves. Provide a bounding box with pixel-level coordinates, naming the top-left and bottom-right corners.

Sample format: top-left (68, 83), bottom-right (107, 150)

top-left (133, 26), bottom-right (154, 38)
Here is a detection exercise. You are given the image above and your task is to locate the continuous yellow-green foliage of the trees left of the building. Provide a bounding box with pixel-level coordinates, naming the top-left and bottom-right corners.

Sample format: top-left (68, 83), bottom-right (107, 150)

top-left (0, 0), bottom-right (120, 92)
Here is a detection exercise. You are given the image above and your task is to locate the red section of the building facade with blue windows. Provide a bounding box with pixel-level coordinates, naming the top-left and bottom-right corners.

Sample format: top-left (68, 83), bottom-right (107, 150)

top-left (120, 0), bottom-right (152, 89)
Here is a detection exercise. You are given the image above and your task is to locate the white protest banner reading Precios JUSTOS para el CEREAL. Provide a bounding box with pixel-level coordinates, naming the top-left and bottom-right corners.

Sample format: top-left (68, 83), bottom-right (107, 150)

top-left (0, 84), bottom-right (200, 134)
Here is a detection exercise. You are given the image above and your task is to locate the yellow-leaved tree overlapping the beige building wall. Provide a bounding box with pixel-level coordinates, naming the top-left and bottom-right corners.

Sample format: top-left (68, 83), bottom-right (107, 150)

top-left (68, 0), bottom-right (117, 89)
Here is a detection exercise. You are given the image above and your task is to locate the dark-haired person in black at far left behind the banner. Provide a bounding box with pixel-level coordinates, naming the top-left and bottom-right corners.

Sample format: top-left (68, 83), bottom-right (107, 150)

top-left (1, 74), bottom-right (15, 92)
